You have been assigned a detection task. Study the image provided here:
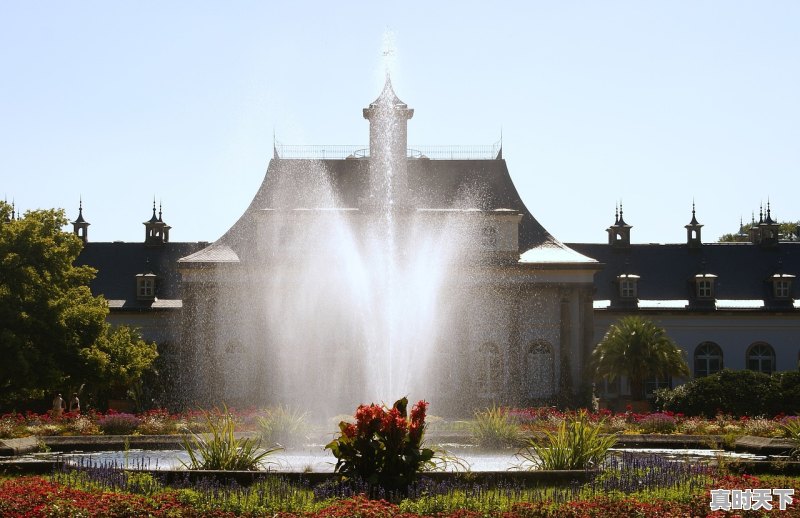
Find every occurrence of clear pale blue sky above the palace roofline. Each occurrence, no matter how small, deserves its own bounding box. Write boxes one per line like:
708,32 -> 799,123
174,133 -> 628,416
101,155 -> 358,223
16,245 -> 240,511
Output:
0,0 -> 800,246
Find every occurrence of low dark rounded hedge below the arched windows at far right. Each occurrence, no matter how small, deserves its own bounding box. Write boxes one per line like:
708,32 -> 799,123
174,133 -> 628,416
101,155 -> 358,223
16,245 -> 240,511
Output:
654,369 -> 800,417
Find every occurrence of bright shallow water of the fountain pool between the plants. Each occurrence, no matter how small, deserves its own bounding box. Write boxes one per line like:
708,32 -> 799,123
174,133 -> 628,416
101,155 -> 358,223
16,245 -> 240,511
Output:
28,448 -> 766,473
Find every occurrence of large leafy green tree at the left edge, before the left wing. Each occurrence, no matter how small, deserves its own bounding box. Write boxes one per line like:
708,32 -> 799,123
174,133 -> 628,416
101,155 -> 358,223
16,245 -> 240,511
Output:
0,202 -> 155,408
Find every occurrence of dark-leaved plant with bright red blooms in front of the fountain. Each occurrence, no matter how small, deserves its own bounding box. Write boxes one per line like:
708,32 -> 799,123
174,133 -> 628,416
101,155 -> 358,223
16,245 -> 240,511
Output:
325,398 -> 434,495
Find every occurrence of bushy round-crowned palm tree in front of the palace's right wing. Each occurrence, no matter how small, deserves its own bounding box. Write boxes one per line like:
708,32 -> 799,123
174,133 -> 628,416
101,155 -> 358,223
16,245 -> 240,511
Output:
591,316 -> 689,401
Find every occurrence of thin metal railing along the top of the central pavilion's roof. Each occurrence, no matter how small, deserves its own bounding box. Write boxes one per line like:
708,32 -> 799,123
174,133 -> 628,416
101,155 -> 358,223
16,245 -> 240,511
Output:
275,142 -> 501,160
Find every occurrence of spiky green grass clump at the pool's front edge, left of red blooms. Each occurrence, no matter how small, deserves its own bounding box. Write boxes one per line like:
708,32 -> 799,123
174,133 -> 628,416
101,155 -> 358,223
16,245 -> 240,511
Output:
183,408 -> 280,471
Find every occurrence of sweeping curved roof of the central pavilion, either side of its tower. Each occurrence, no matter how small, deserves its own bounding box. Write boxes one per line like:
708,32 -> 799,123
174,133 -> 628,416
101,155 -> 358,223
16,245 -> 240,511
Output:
180,158 -> 564,262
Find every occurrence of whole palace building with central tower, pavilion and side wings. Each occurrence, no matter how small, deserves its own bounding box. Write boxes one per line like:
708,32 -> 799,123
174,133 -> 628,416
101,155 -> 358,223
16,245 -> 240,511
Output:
73,79 -> 800,414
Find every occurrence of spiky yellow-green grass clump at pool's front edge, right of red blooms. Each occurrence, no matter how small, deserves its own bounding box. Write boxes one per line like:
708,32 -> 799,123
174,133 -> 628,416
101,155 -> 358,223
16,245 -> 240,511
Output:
517,410 -> 617,470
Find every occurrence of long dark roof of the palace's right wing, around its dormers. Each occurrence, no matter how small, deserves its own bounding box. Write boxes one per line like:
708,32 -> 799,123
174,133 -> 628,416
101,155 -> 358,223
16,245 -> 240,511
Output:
567,242 -> 800,305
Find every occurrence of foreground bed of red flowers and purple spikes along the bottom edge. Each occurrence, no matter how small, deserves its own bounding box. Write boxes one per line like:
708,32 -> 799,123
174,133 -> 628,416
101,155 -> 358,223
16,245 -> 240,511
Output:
0,466 -> 800,518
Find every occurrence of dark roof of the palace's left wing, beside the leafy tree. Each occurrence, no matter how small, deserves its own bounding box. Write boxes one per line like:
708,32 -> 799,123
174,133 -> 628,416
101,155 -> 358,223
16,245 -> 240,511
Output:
75,242 -> 206,309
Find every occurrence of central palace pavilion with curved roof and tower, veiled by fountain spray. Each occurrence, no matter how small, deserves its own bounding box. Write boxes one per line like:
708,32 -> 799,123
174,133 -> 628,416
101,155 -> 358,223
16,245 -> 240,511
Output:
177,58 -> 596,416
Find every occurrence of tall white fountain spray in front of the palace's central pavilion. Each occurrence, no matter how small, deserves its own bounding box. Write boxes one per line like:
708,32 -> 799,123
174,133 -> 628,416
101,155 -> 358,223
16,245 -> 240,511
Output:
180,77 -> 489,415
